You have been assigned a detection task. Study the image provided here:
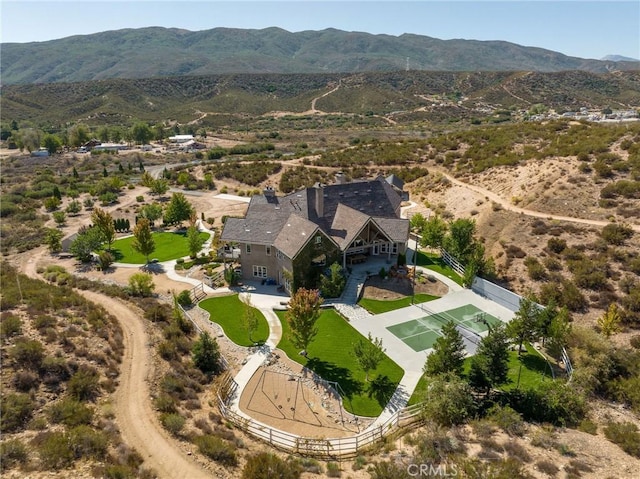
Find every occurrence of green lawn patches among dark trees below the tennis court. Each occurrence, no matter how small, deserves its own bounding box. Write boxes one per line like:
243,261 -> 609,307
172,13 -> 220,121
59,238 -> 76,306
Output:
409,344 -> 553,405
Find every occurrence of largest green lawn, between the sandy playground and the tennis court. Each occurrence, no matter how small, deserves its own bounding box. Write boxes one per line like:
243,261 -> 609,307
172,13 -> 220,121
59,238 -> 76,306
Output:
276,309 -> 404,417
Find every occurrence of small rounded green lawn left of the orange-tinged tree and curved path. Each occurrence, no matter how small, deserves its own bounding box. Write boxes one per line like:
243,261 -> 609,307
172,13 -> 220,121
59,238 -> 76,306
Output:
199,294 -> 269,346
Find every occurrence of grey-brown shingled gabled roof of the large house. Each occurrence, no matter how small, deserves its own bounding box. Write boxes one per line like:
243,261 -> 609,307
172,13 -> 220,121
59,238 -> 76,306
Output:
221,177 -> 409,258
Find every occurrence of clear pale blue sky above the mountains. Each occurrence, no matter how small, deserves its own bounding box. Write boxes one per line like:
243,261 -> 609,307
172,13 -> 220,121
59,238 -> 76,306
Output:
0,0 -> 640,58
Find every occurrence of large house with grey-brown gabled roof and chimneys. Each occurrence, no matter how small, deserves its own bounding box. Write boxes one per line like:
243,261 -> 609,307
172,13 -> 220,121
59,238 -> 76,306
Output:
221,174 -> 409,293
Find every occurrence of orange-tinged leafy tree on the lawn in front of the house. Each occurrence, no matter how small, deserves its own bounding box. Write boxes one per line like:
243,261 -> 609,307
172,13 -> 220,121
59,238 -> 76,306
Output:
286,288 -> 323,351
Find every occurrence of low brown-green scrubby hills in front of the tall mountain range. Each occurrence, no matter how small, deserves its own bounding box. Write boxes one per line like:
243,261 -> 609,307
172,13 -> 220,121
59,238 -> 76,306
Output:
0,71 -> 640,125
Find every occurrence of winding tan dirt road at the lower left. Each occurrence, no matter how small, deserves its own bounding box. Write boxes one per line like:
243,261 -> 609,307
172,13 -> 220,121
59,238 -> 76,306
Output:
20,248 -> 211,479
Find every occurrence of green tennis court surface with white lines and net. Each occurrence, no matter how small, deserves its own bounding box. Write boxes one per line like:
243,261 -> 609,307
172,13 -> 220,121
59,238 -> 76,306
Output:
387,304 -> 501,352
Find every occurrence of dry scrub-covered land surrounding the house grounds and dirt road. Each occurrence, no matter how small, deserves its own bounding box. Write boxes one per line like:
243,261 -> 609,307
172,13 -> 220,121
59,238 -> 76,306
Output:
1,117 -> 640,478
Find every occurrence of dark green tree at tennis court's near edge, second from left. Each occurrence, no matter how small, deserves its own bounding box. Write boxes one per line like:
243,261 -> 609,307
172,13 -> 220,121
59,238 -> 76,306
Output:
469,325 -> 509,394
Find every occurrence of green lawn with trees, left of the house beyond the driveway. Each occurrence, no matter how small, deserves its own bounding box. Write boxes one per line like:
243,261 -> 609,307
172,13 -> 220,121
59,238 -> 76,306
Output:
111,231 -> 209,264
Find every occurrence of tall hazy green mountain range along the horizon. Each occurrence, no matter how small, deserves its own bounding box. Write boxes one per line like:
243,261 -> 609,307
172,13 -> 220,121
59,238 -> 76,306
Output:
0,27 -> 640,85
